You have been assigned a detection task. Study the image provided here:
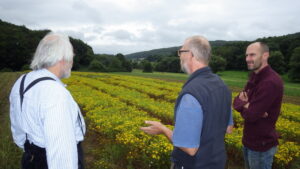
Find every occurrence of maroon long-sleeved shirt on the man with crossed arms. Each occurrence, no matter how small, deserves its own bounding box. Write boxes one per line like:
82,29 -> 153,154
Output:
233,66 -> 283,152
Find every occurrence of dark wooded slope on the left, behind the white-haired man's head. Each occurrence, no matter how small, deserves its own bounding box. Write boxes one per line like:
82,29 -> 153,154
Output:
0,20 -> 132,72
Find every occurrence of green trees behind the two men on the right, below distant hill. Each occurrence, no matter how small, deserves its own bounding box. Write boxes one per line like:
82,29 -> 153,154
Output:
130,33 -> 300,81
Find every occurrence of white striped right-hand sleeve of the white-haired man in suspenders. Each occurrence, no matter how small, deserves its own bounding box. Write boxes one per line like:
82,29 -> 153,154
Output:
41,87 -> 78,169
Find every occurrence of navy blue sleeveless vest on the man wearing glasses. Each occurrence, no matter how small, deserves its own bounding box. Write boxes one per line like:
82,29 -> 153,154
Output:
171,67 -> 231,169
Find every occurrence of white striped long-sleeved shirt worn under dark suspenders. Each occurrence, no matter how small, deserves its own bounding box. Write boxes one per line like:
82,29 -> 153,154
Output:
9,69 -> 85,169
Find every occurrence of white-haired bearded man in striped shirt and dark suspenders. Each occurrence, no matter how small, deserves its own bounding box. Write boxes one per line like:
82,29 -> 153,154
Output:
10,33 -> 85,169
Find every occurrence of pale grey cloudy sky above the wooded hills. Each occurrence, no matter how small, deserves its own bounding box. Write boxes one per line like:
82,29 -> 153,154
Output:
0,0 -> 300,54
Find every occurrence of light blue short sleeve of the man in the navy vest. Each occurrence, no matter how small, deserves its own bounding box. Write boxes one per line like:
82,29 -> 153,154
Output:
172,94 -> 203,148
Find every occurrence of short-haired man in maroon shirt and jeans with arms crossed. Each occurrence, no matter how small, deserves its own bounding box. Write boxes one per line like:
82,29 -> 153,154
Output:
233,42 -> 283,169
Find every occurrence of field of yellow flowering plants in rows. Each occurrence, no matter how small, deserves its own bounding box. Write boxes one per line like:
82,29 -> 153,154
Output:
64,72 -> 300,169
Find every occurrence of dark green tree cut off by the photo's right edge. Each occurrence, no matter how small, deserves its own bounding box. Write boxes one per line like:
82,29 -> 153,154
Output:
288,46 -> 300,81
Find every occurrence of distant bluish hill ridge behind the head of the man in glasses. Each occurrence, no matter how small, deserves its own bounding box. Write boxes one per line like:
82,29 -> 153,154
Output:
125,40 -> 246,59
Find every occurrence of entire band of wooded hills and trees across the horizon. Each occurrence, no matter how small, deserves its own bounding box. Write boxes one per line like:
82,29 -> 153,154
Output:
0,20 -> 300,81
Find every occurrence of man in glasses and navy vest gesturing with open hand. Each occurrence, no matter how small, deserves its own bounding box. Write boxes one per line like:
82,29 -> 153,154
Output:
141,36 -> 233,169
